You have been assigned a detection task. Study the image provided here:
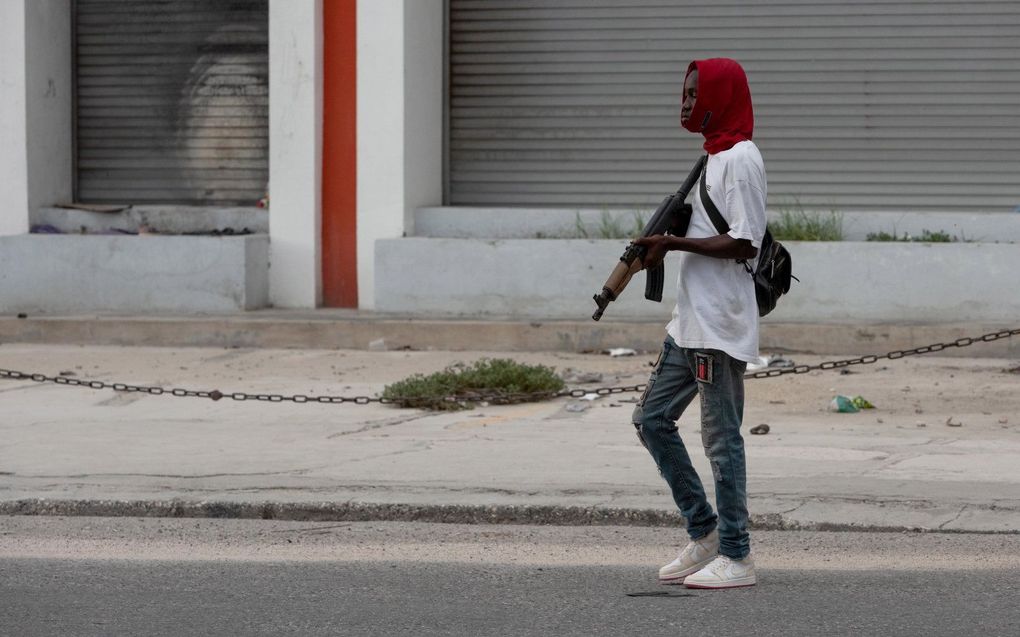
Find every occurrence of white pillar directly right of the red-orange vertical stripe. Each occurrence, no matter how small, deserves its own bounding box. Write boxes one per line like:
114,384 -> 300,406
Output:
357,0 -> 444,309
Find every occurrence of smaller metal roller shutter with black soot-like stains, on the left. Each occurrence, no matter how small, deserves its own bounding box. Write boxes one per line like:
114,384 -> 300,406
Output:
74,0 -> 269,205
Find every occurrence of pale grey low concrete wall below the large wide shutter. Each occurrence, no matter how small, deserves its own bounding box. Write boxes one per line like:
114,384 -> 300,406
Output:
375,237 -> 1020,323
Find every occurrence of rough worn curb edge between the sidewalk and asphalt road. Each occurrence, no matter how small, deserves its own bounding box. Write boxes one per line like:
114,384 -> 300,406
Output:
0,498 -> 1020,535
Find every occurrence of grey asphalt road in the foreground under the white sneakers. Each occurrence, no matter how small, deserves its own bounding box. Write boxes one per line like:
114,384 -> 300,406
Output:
0,518 -> 1020,636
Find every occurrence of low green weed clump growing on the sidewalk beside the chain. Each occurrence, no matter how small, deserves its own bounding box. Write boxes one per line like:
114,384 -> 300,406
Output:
383,359 -> 564,411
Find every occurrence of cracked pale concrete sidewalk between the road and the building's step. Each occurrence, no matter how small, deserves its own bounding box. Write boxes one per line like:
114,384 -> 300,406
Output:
0,332 -> 1020,533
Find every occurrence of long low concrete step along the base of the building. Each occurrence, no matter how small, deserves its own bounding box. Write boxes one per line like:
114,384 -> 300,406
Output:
0,310 -> 1020,358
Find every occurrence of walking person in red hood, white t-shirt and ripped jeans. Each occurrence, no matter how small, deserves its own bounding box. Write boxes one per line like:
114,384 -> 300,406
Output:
633,58 -> 766,588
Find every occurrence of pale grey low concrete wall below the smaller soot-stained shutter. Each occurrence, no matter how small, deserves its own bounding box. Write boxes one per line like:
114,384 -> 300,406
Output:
0,234 -> 269,313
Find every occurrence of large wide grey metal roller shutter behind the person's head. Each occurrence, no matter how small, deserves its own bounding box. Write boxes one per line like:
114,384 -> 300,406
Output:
448,0 -> 1020,212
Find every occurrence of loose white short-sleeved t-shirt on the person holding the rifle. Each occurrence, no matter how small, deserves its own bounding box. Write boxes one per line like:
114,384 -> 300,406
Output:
666,141 -> 767,363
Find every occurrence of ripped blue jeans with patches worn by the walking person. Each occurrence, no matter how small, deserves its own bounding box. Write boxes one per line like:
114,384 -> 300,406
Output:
632,336 -> 751,560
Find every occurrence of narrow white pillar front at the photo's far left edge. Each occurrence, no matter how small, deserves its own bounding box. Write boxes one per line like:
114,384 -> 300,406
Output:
0,0 -> 29,236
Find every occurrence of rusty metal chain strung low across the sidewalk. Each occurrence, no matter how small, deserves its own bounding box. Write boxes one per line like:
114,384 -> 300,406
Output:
0,328 -> 1020,407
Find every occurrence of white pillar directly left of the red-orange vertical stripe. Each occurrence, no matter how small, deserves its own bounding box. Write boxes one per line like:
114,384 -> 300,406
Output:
269,0 -> 322,308
